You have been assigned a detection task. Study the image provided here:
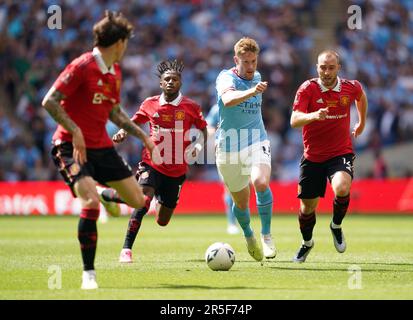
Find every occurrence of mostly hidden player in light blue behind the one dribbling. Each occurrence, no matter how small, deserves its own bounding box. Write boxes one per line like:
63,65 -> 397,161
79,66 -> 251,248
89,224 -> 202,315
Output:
205,104 -> 239,234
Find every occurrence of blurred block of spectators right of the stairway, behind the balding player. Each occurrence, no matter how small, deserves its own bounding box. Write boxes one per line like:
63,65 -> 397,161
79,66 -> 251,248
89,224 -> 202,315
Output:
337,0 -> 413,152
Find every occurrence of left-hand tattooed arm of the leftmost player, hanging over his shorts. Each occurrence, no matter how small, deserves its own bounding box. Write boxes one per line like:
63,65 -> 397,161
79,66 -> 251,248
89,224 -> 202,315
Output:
42,87 -> 87,164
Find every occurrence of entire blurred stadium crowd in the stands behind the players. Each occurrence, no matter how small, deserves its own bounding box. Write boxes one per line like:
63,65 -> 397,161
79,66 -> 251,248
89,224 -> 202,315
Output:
0,0 -> 413,181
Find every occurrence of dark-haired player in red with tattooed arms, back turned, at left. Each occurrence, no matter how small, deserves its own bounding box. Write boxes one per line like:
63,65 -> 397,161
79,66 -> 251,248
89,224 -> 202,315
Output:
42,12 -> 159,289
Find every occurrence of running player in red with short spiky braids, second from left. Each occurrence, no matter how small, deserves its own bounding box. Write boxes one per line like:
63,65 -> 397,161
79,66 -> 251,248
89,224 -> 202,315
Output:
98,60 -> 208,262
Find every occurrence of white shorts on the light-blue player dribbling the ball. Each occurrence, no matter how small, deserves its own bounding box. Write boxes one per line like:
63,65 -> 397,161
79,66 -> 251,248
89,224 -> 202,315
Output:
216,140 -> 271,192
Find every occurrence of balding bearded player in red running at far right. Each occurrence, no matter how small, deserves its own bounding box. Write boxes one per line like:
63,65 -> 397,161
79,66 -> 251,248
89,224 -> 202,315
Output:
290,50 -> 367,262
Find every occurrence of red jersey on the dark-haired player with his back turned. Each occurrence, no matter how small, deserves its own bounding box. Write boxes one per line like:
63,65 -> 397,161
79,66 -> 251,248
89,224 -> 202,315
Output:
53,48 -> 122,149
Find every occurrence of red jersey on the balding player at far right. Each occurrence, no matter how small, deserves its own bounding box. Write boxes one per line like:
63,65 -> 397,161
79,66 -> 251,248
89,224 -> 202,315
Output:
293,78 -> 363,162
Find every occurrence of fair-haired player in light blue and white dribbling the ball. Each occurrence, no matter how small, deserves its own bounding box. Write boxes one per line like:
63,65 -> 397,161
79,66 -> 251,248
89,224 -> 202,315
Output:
216,37 -> 276,261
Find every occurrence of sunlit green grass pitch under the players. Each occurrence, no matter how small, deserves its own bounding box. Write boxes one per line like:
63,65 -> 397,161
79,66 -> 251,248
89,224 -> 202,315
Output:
0,215 -> 413,300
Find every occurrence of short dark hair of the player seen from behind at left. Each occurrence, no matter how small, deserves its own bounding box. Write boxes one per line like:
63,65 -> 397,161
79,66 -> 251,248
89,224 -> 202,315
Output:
93,10 -> 133,48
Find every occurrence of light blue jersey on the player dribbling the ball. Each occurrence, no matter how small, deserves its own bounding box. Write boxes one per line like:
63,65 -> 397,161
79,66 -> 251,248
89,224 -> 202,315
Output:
216,68 -> 267,152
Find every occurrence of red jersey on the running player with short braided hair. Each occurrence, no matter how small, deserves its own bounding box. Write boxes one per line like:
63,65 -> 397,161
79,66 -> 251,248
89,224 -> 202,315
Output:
132,94 -> 207,177
